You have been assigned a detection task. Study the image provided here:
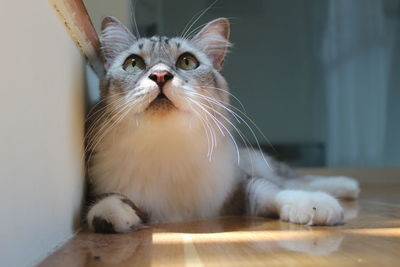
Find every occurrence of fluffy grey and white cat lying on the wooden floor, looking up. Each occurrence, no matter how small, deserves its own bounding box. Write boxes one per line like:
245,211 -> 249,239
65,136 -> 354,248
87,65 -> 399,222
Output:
86,17 -> 360,233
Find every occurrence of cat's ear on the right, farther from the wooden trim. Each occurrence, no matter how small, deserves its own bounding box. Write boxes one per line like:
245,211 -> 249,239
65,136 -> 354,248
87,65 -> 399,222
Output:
192,18 -> 230,70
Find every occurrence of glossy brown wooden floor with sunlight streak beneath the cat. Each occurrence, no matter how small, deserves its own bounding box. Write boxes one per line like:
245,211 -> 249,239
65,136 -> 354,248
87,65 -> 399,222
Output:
40,170 -> 400,267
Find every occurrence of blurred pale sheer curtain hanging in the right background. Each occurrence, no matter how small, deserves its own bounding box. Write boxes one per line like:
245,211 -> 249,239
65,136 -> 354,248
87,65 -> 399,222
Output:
321,0 -> 400,166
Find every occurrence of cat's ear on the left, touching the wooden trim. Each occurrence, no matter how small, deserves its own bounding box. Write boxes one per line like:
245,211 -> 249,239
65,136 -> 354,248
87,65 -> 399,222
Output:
100,17 -> 136,70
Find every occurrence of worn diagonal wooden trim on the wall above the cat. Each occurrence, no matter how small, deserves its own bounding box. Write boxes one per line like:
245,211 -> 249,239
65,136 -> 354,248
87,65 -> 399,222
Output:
49,0 -> 104,77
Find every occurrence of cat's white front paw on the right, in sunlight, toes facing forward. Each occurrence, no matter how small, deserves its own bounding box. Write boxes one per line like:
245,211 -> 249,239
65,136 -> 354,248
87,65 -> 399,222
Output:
276,190 -> 343,225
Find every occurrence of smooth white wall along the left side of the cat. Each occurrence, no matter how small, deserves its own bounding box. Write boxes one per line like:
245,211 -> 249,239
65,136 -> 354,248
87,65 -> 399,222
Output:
0,0 -> 85,266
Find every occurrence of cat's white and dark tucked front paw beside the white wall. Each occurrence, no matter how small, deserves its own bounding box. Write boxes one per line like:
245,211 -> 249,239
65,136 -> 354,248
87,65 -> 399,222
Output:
86,193 -> 147,233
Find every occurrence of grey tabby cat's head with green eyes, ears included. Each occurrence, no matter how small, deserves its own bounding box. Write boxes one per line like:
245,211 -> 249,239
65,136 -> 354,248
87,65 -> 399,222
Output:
100,17 -> 229,121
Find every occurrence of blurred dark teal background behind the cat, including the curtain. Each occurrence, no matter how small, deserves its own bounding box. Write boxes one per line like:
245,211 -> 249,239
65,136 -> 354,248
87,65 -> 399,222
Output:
84,0 -> 400,167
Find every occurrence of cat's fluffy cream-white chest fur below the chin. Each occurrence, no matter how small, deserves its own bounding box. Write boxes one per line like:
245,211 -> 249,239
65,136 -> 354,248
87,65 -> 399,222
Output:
90,113 -> 237,222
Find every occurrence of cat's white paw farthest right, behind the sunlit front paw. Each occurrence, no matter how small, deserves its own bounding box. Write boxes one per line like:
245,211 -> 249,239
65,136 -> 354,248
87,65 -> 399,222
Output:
310,176 -> 360,199
